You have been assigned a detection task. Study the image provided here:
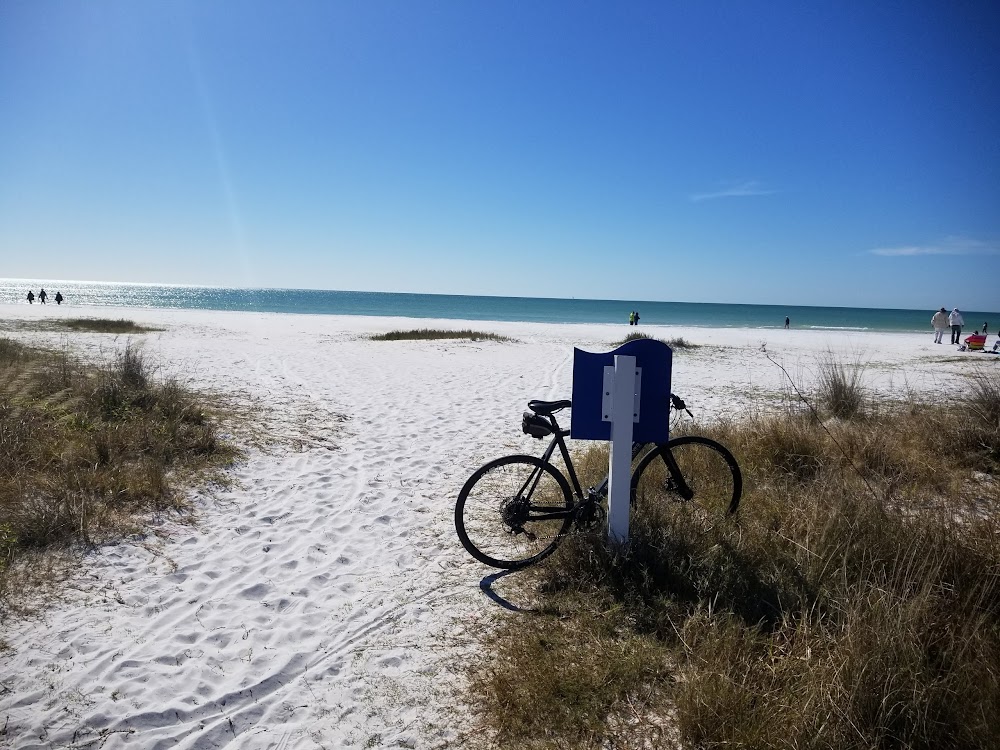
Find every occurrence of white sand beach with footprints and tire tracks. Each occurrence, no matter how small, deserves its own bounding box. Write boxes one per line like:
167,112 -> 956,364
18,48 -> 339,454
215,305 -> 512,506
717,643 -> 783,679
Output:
0,305 -> 1000,750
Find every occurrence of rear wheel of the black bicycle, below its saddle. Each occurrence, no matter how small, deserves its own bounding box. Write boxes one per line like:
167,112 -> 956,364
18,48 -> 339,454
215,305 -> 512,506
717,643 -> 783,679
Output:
455,455 -> 573,569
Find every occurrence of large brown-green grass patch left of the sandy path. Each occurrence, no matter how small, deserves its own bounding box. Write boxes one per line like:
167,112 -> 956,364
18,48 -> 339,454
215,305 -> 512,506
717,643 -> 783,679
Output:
0,339 -> 237,606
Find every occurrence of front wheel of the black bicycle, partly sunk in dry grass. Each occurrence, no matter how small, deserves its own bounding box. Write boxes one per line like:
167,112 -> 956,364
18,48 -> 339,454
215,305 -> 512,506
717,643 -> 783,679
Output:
632,435 -> 743,516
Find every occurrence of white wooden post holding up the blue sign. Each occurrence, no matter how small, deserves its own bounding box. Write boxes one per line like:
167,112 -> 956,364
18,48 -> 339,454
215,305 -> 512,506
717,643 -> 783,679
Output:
602,354 -> 642,544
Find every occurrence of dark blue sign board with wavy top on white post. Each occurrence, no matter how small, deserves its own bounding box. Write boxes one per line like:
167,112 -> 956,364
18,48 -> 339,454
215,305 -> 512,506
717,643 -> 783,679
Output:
570,339 -> 674,443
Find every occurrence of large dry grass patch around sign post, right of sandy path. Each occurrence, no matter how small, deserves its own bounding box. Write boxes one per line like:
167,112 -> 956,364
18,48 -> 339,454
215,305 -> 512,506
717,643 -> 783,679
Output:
469,362 -> 1000,750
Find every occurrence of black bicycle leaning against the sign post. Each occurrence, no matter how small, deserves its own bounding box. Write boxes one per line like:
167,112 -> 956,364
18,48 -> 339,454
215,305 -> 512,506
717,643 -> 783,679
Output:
455,394 -> 743,570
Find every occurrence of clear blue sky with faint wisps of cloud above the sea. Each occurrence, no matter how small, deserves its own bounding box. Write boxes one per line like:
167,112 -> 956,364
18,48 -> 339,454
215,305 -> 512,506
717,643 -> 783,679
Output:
0,0 -> 1000,310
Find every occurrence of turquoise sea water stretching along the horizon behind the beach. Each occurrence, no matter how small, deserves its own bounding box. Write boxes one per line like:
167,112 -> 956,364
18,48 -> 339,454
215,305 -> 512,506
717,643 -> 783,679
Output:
0,279 -> 1000,332
